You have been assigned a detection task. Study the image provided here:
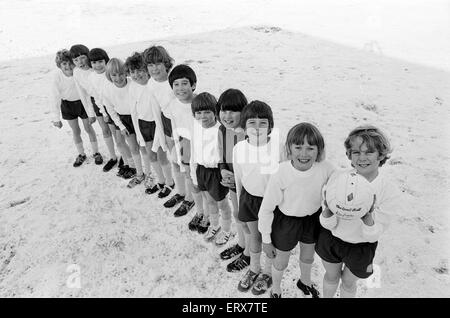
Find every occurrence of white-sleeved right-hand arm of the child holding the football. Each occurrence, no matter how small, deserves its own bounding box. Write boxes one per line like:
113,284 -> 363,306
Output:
361,184 -> 401,242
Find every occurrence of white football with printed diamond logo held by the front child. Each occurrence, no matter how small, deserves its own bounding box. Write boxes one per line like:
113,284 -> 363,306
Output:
324,171 -> 375,220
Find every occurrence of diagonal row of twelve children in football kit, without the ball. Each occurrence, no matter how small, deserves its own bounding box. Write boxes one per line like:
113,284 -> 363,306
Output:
53,45 -> 398,297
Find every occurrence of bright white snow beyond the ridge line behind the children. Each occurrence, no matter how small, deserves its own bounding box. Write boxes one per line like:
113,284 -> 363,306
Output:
0,0 -> 450,70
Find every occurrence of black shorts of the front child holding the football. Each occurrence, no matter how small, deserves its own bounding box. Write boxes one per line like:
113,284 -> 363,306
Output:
315,228 -> 378,278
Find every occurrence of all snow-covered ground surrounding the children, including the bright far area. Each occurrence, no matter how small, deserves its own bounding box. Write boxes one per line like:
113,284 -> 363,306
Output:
0,0 -> 450,297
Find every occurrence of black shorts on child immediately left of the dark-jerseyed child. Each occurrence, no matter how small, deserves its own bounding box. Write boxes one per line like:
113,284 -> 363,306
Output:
195,165 -> 228,202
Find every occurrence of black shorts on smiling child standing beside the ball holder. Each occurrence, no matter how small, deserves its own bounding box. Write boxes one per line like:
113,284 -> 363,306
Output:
271,207 -> 322,252
